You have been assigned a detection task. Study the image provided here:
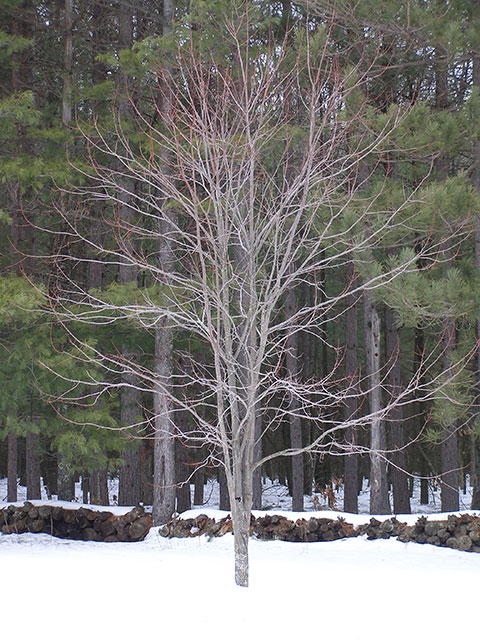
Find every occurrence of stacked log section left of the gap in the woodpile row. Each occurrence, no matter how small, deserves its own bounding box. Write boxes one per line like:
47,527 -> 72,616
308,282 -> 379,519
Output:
0,502 -> 152,542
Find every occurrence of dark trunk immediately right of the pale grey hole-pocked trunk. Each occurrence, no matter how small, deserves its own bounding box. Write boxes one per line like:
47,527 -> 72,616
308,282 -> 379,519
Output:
385,307 -> 411,513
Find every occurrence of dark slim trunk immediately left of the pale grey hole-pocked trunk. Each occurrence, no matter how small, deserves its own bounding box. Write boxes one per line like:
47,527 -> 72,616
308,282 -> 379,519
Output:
343,261 -> 359,513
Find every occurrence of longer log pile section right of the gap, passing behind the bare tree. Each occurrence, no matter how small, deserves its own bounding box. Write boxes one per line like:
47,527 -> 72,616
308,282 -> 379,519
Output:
160,514 -> 480,553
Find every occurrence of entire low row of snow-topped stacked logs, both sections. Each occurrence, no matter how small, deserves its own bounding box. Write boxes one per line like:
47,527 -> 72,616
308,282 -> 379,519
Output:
0,502 -> 480,553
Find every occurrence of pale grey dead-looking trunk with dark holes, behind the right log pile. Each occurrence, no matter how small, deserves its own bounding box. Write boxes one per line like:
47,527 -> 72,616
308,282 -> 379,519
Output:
363,290 -> 390,514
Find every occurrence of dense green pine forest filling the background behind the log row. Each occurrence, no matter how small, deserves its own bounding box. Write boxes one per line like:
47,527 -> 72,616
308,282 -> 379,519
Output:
0,0 -> 480,556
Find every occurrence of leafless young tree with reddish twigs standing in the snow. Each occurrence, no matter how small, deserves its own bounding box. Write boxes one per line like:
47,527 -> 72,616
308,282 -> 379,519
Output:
49,16 -> 462,586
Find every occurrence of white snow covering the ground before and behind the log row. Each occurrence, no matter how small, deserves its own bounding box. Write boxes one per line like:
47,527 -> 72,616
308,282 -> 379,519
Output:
0,481 -> 480,640
